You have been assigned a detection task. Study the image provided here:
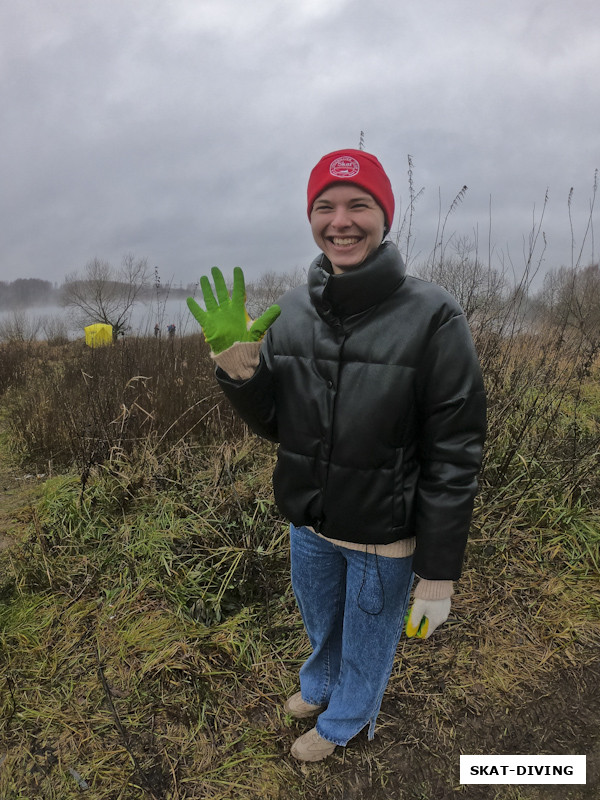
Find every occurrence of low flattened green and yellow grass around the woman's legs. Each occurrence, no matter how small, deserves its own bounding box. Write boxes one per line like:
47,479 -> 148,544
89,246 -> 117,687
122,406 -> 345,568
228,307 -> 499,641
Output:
0,432 -> 600,800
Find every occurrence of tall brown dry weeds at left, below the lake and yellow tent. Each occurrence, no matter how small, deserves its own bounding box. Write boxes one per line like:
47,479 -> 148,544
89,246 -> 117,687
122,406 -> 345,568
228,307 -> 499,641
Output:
0,334 -> 244,471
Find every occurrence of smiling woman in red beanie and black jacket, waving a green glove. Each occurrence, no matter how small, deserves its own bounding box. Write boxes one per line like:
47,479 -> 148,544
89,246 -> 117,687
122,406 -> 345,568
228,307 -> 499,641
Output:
189,149 -> 485,761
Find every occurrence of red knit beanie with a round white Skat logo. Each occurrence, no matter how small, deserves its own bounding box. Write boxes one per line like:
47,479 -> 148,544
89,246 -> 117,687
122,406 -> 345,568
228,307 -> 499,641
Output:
307,149 -> 394,230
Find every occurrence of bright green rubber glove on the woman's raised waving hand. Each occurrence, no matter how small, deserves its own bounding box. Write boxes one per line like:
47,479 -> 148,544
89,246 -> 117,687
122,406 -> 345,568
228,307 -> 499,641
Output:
187,267 -> 281,355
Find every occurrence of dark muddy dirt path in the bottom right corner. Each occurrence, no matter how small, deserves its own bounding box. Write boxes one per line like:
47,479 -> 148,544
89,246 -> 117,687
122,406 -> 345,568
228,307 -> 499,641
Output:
296,658 -> 600,800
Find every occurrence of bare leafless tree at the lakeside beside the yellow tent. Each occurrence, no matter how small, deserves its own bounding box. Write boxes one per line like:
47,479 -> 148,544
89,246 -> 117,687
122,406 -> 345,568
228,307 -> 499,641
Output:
62,253 -> 149,338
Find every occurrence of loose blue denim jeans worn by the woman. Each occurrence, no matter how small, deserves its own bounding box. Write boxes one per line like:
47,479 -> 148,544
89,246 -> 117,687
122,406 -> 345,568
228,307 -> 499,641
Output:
290,525 -> 414,746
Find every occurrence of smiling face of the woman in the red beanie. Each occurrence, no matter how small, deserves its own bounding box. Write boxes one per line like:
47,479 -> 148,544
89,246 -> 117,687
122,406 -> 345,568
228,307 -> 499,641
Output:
310,183 -> 385,274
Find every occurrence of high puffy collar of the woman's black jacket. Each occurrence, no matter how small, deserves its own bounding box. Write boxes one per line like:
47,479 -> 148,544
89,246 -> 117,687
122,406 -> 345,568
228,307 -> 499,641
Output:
308,242 -> 406,321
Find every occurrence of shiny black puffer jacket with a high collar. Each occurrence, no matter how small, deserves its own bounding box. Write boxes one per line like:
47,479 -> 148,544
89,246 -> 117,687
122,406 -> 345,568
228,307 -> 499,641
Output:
217,242 -> 485,580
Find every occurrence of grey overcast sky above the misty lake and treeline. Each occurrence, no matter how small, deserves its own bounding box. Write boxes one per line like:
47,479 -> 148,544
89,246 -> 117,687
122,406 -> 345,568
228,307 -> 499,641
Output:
0,0 -> 600,285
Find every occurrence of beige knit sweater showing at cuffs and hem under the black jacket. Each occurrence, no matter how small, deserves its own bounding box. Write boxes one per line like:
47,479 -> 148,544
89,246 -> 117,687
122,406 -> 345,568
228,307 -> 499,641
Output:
212,342 -> 454,600
